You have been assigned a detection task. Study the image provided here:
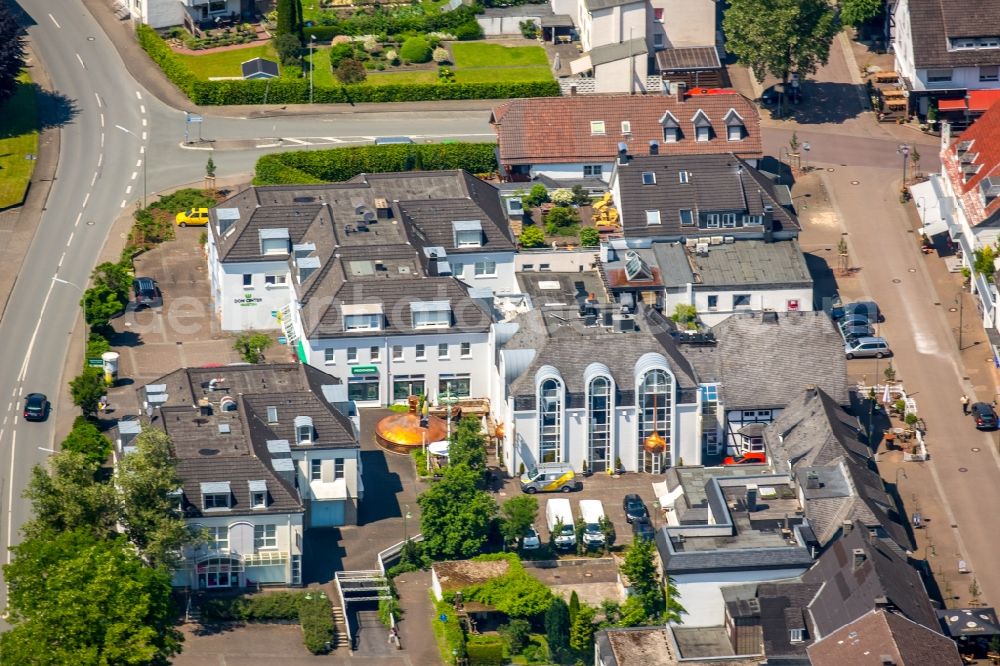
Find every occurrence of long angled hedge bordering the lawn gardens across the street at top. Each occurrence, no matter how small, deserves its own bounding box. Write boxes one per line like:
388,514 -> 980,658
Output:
136,24 -> 559,106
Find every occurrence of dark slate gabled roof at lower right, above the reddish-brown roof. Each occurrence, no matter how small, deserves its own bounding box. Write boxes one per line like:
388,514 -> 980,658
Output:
802,524 -> 939,635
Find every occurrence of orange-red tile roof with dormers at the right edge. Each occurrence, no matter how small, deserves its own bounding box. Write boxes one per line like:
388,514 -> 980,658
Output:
941,104 -> 1000,227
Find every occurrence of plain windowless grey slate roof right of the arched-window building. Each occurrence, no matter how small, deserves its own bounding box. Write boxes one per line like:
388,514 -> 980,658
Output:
704,312 -> 850,409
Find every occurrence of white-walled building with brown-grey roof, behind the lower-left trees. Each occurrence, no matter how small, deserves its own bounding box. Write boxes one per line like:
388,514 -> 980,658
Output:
125,364 -> 364,589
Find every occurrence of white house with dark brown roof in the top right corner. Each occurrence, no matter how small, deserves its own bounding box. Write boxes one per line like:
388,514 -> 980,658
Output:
890,0 -> 1000,116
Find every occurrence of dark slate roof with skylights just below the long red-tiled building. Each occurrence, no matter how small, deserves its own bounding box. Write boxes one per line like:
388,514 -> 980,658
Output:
615,153 -> 799,238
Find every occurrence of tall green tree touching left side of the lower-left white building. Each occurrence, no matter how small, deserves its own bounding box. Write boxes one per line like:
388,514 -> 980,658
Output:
115,428 -> 196,568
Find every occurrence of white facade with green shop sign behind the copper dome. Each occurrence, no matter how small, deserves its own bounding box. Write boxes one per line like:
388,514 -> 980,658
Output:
307,332 -> 493,407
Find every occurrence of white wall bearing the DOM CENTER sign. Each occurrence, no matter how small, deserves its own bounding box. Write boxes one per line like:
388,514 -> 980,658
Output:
217,256 -> 294,331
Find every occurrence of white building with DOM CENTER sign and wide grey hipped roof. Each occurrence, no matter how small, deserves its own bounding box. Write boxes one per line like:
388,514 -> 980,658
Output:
207,171 -> 518,331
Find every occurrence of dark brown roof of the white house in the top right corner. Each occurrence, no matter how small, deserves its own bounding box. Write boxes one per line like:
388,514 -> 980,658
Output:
908,0 -> 1000,68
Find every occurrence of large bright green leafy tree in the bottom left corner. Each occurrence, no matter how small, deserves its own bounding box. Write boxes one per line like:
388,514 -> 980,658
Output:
0,531 -> 181,666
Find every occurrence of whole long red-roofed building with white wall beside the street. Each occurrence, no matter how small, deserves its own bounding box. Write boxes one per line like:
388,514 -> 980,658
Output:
490,88 -> 763,187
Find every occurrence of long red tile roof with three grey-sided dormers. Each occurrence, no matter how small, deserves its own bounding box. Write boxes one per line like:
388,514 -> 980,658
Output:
490,91 -> 763,165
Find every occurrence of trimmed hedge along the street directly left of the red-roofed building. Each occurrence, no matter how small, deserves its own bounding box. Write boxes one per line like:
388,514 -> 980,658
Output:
254,143 -> 497,185
